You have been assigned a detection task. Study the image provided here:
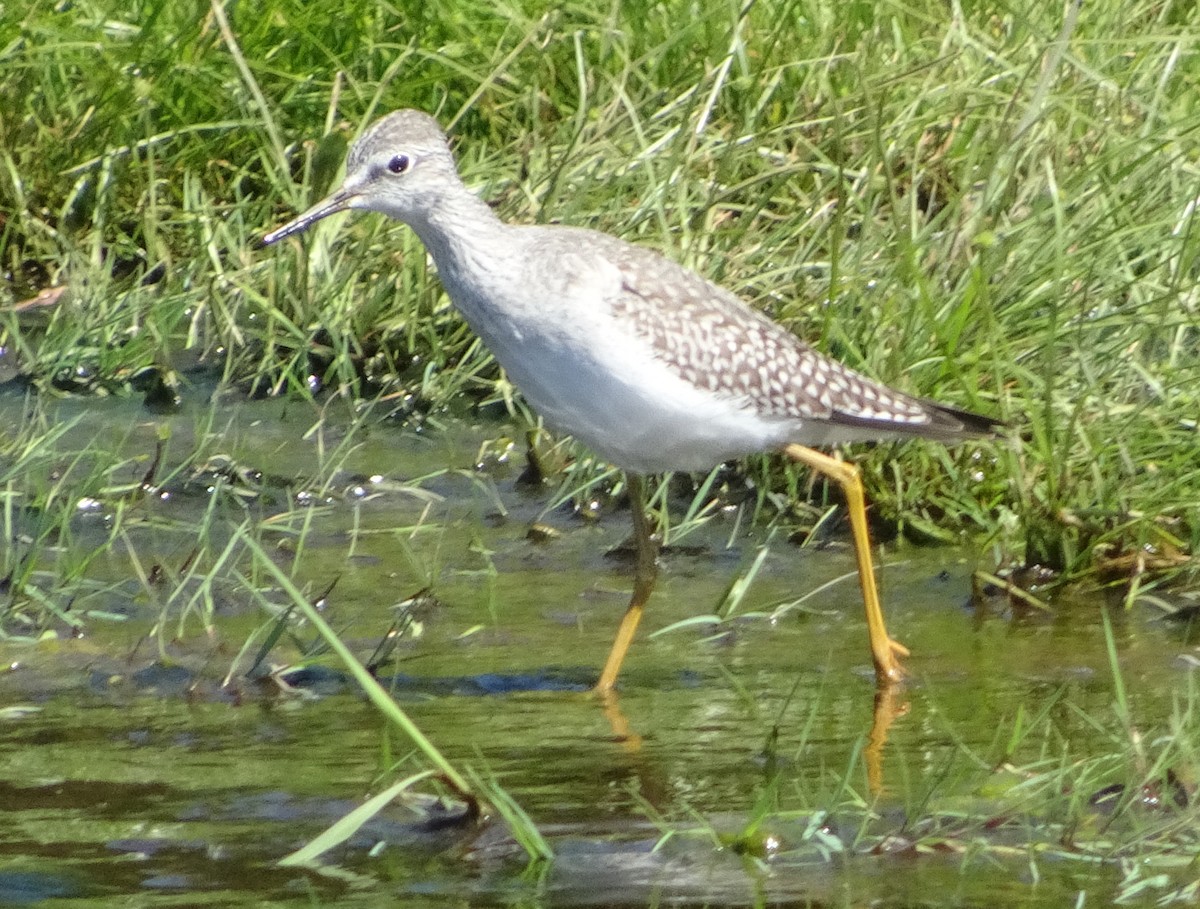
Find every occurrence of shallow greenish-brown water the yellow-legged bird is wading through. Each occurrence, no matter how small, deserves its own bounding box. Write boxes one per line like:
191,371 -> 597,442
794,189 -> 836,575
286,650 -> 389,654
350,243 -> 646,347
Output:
0,390 -> 1190,907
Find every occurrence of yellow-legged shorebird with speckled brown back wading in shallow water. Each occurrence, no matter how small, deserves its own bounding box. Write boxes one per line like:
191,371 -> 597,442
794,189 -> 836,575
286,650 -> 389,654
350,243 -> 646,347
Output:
263,110 -> 997,692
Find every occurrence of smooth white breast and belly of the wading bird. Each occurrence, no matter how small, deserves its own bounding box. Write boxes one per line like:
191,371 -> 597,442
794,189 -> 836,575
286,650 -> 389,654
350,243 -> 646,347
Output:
439,231 -> 798,474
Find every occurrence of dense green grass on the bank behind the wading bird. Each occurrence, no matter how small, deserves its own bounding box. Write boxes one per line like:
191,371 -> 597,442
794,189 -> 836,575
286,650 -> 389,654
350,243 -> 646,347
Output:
0,0 -> 1200,590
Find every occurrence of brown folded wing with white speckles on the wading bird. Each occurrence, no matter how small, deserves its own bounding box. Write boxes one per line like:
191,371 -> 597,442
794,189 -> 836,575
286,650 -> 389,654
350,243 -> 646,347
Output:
608,243 -> 940,437
